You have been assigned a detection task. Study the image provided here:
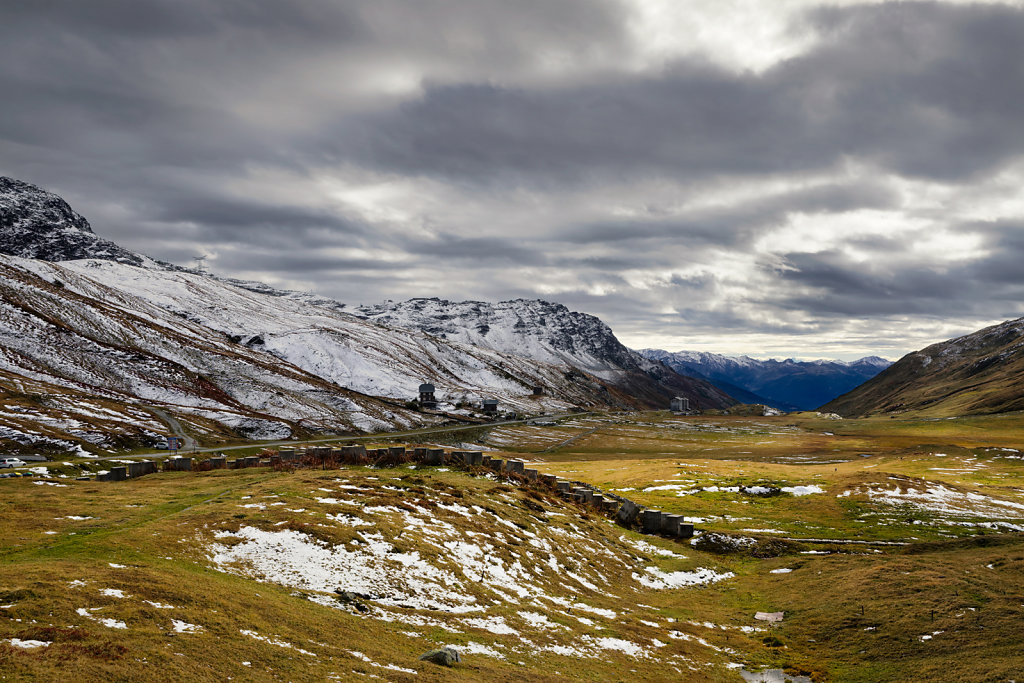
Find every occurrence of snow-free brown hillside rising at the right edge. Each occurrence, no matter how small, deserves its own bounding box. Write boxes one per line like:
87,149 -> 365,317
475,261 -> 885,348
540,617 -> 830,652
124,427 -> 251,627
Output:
821,318 -> 1024,417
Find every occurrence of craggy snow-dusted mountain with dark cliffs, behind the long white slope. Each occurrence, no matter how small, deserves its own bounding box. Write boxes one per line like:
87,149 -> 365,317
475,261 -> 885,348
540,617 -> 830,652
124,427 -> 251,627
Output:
353,298 -> 735,408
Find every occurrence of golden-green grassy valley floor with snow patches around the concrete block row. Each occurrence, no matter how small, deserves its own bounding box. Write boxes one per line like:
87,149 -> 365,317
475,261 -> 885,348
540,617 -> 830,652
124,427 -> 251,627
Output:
0,413 -> 1024,681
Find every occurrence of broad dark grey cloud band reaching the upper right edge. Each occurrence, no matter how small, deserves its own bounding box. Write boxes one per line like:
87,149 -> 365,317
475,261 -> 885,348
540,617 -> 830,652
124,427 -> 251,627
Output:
342,3 -> 1024,182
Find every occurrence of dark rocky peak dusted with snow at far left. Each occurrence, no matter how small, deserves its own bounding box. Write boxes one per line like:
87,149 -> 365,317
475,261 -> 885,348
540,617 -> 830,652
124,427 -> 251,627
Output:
0,176 -> 147,265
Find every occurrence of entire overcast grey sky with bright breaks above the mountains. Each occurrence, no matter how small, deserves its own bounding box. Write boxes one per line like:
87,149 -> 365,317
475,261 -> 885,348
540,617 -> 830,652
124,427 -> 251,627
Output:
0,0 -> 1024,359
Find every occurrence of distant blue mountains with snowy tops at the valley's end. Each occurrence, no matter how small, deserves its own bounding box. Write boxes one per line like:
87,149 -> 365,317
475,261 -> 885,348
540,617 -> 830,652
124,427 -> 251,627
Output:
640,349 -> 892,411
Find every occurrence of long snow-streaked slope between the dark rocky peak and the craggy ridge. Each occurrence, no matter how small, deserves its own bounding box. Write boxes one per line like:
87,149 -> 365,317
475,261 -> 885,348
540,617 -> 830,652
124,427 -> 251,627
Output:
0,250 -> 629,454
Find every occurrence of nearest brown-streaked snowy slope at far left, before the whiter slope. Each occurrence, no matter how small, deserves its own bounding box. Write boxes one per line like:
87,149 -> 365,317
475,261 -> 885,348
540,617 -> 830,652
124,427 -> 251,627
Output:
0,256 -> 431,442
